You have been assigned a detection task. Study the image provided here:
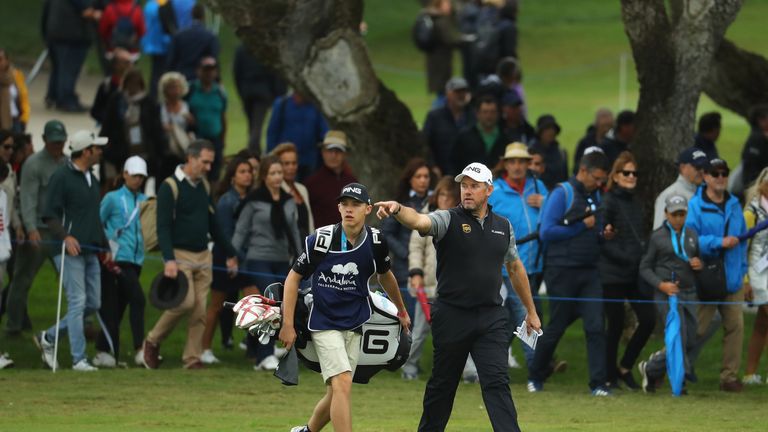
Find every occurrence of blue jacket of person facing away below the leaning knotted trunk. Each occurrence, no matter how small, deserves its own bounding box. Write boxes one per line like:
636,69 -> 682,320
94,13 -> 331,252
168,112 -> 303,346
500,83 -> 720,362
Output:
267,95 -> 328,172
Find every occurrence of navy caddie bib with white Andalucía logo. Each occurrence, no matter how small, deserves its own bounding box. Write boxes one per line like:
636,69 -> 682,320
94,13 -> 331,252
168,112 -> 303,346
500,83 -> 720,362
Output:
308,225 -> 380,331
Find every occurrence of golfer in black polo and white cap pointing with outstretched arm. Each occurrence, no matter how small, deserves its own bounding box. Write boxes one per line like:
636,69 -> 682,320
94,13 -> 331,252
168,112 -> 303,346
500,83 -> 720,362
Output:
375,163 -> 541,432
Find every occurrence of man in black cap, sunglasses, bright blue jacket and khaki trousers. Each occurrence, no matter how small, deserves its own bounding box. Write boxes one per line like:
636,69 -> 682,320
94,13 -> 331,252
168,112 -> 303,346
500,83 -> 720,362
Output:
685,159 -> 747,392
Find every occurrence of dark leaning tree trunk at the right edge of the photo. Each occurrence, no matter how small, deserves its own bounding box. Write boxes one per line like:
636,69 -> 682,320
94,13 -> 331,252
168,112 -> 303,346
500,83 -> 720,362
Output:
704,39 -> 768,119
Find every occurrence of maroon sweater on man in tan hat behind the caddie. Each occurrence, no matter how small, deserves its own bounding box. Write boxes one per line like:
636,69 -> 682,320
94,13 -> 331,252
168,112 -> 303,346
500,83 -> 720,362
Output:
304,164 -> 357,228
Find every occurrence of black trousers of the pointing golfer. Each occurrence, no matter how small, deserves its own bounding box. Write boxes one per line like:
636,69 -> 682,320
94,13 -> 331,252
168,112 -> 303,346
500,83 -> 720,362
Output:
418,301 -> 520,432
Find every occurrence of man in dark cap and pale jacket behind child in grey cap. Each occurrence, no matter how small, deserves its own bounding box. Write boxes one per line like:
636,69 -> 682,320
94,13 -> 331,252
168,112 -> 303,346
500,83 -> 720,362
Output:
653,147 -> 709,230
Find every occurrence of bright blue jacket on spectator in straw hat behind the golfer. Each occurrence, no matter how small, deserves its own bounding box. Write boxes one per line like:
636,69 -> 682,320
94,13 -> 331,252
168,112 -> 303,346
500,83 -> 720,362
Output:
488,177 -> 549,276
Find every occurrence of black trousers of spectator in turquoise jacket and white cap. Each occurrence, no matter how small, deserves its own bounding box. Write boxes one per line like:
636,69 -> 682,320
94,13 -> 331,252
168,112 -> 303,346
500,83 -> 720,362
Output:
96,262 -> 146,359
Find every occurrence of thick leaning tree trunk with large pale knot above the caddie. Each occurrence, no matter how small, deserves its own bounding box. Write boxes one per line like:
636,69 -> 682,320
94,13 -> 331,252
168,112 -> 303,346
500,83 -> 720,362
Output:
206,0 -> 425,200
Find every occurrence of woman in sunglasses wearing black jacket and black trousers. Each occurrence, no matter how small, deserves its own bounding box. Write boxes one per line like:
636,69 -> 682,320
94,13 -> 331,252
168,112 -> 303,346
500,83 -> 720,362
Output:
599,152 -> 656,390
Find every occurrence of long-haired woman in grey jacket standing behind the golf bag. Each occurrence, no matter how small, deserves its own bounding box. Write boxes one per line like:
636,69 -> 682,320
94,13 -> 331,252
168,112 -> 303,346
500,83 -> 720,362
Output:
232,156 -> 302,370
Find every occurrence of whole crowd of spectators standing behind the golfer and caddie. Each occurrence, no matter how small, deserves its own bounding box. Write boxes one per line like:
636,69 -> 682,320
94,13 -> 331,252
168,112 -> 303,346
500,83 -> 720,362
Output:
0,0 -> 768,402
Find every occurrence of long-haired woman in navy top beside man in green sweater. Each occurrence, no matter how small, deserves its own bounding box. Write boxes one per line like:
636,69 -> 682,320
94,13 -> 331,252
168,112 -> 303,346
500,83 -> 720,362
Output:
200,157 -> 253,364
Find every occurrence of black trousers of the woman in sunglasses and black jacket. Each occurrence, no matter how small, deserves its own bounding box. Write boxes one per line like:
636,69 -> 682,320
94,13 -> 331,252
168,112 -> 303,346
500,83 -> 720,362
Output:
603,283 -> 656,381
